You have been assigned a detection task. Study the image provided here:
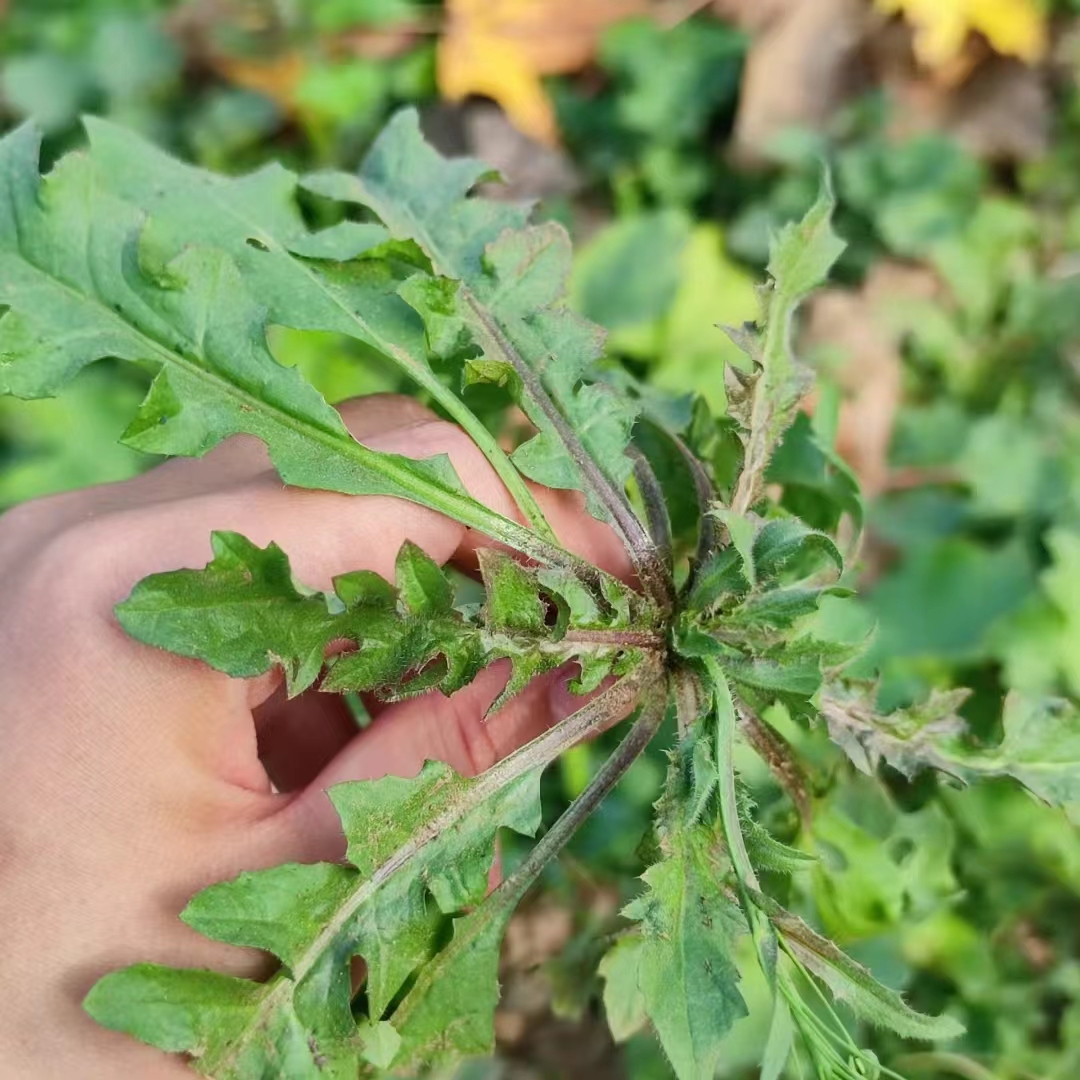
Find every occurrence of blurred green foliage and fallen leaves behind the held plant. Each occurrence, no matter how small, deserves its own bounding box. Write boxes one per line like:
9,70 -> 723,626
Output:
6,0 -> 1080,1080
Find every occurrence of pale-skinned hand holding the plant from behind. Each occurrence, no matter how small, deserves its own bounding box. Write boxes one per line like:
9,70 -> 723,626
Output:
0,396 -> 626,1080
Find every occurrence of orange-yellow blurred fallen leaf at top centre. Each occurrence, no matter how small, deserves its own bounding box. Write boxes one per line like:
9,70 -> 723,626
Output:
437,0 -> 649,145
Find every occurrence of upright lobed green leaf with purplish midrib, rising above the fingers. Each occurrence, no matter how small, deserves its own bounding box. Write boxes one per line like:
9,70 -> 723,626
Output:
305,110 -> 634,517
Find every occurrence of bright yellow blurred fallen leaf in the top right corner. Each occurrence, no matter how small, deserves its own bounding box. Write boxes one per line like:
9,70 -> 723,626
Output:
877,0 -> 1048,68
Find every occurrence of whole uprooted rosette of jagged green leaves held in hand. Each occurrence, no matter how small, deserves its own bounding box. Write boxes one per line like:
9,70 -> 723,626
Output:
0,112 -> 1080,1080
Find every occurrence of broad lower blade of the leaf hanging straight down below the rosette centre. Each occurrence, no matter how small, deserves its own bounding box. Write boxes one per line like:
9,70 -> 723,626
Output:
624,827 -> 746,1080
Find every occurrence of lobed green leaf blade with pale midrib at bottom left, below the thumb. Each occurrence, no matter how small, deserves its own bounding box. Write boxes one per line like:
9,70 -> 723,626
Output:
85,755 -> 540,1080
